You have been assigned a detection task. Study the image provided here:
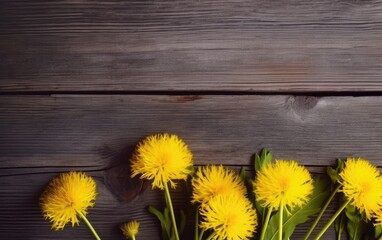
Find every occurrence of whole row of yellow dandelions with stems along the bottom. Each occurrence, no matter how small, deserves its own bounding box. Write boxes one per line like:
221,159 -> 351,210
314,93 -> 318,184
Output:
40,134 -> 382,240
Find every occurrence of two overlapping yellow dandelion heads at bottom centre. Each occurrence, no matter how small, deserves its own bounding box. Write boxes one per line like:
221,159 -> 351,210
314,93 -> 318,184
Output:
192,166 -> 257,240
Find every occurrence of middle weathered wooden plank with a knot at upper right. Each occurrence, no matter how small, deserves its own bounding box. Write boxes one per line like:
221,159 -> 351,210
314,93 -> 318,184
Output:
0,95 -> 382,168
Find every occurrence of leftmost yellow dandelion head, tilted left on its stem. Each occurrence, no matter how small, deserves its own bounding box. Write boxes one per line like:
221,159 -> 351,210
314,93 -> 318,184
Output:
40,172 -> 97,230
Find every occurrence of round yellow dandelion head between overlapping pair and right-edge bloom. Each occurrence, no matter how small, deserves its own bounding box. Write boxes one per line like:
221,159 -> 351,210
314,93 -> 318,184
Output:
254,160 -> 313,209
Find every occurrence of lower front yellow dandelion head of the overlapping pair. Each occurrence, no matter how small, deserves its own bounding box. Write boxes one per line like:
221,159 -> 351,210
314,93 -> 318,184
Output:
200,194 -> 257,240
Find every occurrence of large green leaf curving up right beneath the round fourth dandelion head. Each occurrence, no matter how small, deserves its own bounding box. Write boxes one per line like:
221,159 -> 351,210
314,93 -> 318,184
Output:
265,177 -> 331,240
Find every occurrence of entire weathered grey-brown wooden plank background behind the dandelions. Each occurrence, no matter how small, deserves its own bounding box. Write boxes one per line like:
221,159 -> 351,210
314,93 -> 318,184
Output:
0,0 -> 382,240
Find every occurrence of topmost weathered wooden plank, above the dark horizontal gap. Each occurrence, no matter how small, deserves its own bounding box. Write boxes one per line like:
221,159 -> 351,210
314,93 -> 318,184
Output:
0,0 -> 382,92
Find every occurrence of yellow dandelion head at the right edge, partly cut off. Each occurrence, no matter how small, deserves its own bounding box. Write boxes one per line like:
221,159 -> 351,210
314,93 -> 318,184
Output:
340,158 -> 382,220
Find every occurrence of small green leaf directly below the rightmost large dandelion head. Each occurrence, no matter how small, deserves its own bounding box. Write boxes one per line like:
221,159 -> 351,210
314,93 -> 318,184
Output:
345,204 -> 367,240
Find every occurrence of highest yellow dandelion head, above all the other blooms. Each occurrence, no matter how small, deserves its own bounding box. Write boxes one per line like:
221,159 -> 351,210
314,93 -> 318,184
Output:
131,134 -> 193,189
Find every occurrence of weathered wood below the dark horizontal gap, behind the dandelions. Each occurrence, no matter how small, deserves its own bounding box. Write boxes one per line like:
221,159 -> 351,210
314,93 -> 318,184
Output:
0,95 -> 382,240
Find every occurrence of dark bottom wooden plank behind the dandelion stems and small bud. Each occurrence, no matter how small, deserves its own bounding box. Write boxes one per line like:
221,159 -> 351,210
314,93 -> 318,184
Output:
0,168 -> 334,240
